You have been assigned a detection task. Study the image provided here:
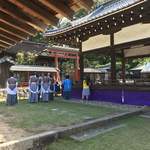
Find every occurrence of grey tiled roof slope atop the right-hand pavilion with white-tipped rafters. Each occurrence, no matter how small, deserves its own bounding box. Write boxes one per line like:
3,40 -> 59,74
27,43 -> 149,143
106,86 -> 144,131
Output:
45,0 -> 141,36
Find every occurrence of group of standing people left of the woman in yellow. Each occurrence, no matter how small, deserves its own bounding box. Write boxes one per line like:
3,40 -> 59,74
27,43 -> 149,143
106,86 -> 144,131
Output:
6,73 -> 72,105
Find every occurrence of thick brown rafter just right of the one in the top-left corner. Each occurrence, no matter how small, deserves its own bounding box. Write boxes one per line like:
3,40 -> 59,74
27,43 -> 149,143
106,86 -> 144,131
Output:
8,0 -> 59,26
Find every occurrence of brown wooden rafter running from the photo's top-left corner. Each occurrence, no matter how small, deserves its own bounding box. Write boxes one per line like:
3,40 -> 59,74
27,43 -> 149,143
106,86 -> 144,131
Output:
0,0 -> 47,31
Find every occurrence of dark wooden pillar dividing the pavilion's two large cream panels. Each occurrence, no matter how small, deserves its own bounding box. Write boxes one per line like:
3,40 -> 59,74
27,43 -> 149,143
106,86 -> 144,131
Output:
110,33 -> 116,83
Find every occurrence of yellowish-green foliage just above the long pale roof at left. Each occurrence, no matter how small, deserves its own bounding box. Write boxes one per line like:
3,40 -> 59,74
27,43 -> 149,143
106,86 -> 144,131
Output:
16,52 -> 37,65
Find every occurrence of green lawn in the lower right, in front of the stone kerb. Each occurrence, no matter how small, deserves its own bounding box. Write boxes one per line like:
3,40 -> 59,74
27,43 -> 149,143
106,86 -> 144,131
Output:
48,117 -> 150,150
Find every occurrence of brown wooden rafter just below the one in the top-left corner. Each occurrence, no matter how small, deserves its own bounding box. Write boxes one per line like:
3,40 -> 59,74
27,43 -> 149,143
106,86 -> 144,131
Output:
0,12 -> 36,36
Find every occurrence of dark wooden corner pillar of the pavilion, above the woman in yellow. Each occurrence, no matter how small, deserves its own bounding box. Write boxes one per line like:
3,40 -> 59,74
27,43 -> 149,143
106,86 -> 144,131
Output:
79,42 -> 84,81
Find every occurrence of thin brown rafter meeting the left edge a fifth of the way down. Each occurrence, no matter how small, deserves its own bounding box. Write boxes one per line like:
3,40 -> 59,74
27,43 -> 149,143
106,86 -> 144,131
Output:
0,28 -> 26,41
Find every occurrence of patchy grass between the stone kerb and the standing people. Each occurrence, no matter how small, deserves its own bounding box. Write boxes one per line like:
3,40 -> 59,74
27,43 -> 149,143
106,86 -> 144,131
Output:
0,100 -> 118,133
